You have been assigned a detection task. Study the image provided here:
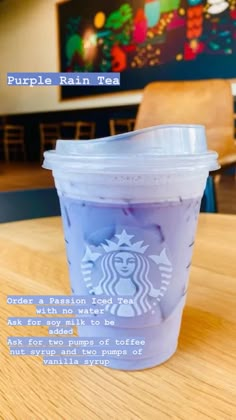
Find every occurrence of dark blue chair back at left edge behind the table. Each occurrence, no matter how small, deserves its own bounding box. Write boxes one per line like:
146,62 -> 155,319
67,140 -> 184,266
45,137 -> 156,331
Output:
0,188 -> 60,223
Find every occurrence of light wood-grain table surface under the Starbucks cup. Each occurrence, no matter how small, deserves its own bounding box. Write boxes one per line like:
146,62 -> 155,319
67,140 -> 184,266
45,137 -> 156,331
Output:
0,214 -> 236,420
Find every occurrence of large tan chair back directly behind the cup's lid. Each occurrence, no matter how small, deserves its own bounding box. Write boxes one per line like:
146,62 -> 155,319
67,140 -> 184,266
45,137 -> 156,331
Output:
135,79 -> 236,157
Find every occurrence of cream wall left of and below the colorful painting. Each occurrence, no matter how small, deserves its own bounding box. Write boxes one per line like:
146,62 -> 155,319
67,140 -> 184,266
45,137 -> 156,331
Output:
0,0 -> 142,115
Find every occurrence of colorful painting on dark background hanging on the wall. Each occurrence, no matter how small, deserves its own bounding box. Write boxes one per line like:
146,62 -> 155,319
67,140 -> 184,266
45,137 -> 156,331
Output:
58,0 -> 236,97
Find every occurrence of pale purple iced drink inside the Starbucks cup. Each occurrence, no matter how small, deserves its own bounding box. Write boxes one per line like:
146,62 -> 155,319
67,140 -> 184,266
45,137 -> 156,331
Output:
60,197 -> 201,369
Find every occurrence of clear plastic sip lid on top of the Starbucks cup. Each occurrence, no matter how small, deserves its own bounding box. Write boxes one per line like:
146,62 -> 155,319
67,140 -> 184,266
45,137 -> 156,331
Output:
43,125 -> 219,173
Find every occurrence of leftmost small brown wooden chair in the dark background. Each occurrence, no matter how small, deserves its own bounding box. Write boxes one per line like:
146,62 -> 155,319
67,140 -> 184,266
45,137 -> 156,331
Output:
3,124 -> 26,162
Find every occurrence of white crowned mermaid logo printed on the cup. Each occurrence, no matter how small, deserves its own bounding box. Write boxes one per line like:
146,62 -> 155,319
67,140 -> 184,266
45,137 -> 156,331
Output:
81,229 -> 172,317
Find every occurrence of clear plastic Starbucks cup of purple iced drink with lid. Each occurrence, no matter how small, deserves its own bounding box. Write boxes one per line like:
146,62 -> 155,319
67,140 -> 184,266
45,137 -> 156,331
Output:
43,125 -> 219,370
